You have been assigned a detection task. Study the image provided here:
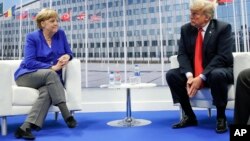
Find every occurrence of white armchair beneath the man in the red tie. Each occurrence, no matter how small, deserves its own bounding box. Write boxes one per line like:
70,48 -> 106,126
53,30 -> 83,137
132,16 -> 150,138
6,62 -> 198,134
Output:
170,52 -> 250,118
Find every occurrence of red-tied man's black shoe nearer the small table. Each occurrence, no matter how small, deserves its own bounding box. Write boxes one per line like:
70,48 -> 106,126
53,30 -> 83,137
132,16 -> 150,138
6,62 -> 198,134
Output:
172,116 -> 198,129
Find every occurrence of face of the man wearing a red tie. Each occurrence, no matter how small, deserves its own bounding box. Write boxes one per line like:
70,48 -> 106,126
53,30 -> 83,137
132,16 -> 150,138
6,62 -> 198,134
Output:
190,10 -> 210,28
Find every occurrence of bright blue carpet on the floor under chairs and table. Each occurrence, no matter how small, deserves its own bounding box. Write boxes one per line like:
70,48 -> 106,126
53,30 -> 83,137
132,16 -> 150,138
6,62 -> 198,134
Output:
0,110 -> 233,141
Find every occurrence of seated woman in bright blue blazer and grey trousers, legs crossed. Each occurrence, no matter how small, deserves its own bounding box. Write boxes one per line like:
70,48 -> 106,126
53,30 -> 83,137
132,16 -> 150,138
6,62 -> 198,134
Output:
15,9 -> 77,140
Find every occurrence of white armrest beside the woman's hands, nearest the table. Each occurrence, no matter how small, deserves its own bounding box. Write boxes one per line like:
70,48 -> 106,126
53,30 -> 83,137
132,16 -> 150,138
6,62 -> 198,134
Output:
64,59 -> 82,110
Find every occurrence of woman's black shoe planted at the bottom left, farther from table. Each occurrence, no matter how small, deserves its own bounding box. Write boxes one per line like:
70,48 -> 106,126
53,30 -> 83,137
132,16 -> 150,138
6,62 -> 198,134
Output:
15,127 -> 35,140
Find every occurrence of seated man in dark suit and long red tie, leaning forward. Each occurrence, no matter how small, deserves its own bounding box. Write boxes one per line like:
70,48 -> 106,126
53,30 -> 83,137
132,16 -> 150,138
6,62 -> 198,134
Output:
166,0 -> 233,133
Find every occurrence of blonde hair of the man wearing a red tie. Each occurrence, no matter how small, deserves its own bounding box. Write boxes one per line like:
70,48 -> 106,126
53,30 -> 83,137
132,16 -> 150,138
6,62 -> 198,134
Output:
190,0 -> 216,19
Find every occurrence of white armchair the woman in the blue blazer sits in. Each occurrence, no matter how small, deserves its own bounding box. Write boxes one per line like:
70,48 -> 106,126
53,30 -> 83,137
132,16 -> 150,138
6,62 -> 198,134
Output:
0,59 -> 81,135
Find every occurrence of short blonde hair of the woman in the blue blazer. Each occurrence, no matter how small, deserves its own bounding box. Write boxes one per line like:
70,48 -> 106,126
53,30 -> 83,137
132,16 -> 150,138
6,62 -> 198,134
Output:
35,8 -> 58,29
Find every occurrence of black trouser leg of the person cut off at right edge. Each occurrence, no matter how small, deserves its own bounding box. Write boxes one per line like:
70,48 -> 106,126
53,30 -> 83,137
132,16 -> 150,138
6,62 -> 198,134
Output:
234,69 -> 250,124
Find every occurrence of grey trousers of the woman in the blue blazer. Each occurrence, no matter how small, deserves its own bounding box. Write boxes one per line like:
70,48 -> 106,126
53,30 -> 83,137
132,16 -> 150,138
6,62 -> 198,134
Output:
16,69 -> 66,127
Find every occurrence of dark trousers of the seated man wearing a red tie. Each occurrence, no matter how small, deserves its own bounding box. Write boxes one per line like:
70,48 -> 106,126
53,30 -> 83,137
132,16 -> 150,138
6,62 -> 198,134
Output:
166,68 -> 233,118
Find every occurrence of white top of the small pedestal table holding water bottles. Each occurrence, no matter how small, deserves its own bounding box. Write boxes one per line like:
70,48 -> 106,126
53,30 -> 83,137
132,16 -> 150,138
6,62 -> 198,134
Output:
100,83 -> 156,89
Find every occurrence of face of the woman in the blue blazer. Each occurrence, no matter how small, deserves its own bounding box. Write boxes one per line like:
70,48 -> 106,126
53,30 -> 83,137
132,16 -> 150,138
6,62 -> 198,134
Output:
41,17 -> 58,34
